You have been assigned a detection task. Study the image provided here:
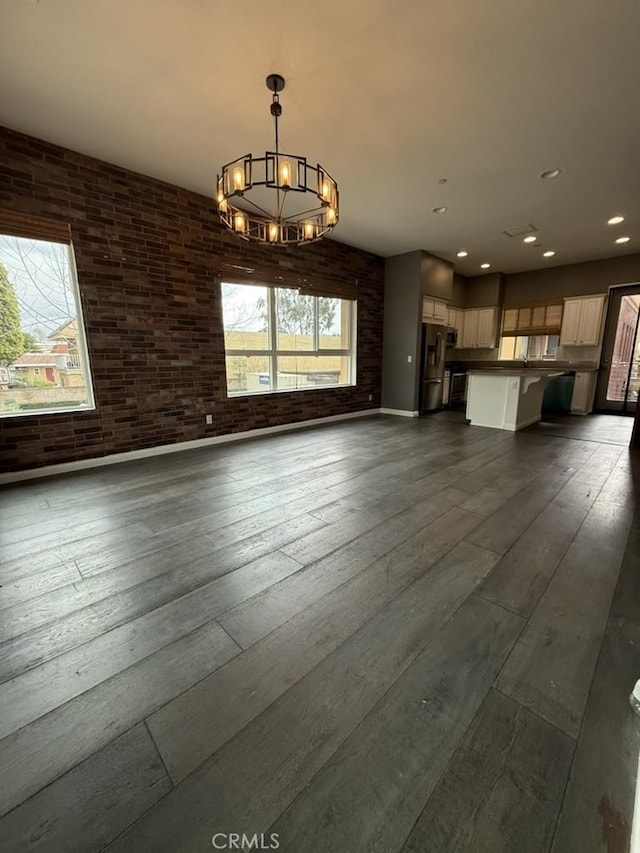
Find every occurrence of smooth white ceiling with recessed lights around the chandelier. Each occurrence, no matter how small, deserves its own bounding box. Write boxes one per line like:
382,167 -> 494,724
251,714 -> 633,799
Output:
0,0 -> 640,275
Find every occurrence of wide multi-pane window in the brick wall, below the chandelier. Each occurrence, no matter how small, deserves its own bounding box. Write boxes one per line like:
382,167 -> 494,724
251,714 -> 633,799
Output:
221,282 -> 355,396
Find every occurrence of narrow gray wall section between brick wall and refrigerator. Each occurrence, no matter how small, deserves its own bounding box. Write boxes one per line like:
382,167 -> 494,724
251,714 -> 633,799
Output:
382,252 -> 422,412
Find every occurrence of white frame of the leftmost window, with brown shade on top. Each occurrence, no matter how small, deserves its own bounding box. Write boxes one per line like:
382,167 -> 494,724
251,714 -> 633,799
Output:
0,231 -> 97,420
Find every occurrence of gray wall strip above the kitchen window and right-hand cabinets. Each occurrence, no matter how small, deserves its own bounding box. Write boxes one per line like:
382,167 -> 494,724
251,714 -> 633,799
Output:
504,254 -> 640,306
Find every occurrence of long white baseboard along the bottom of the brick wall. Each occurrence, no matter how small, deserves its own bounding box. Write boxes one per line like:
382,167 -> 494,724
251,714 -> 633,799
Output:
0,409 -> 381,485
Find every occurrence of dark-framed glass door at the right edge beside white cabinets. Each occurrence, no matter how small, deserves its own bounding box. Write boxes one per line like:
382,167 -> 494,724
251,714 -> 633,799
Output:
596,285 -> 640,414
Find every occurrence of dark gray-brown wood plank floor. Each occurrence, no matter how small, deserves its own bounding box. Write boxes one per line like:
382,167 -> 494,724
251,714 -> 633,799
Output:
0,413 -> 640,853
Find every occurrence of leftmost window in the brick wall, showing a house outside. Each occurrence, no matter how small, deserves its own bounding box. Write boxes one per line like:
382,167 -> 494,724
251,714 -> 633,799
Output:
0,228 -> 93,417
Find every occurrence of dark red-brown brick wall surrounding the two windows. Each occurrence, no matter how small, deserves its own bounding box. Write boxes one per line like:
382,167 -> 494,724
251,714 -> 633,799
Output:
0,128 -> 384,471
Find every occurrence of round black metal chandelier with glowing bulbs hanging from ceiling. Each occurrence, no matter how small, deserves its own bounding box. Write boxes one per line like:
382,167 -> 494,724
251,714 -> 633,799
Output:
216,74 -> 338,245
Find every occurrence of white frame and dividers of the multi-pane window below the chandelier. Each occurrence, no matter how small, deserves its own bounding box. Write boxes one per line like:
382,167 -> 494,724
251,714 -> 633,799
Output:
220,278 -> 358,400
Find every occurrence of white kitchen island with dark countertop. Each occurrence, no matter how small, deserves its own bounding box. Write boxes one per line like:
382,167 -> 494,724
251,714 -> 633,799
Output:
467,367 -> 563,432
